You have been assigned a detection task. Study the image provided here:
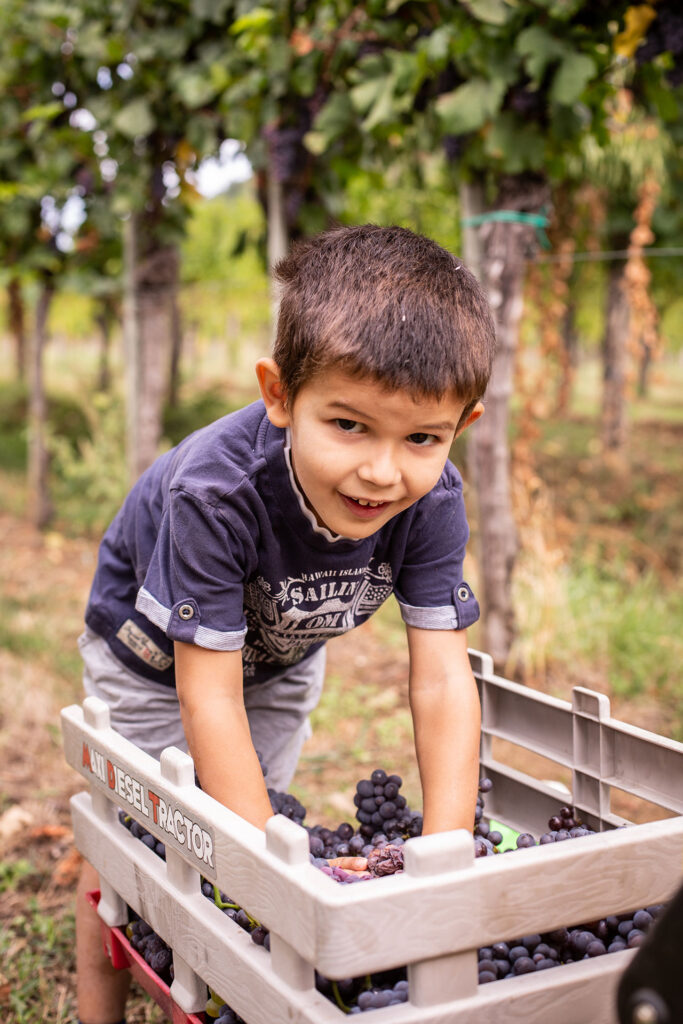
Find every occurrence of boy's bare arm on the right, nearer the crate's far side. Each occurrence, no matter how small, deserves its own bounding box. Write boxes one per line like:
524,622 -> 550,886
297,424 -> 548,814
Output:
407,626 -> 481,835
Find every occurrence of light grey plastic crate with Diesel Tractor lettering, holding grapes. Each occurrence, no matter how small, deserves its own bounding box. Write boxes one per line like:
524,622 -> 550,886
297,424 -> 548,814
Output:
62,651 -> 683,1024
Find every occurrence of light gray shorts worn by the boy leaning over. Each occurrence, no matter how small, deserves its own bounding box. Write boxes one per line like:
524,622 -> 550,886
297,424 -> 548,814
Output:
78,627 -> 326,793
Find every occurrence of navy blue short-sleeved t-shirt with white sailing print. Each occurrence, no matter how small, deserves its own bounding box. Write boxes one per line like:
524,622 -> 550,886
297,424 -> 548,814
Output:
85,401 -> 479,686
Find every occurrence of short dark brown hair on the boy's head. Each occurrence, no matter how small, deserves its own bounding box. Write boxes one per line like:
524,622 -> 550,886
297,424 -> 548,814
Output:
272,224 -> 496,419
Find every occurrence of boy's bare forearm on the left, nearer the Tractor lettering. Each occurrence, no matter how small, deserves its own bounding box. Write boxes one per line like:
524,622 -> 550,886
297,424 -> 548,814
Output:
175,640 -> 272,828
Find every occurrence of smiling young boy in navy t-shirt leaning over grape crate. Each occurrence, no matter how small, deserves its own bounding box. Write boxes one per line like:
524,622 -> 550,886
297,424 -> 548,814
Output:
77,225 -> 495,1024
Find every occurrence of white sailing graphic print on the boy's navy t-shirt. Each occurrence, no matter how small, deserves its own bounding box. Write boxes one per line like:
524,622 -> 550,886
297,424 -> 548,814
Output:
242,559 -> 393,677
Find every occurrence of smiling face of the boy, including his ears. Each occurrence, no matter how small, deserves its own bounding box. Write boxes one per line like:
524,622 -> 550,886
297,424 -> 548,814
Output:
257,359 -> 483,540
